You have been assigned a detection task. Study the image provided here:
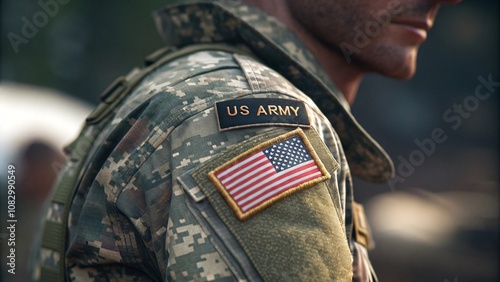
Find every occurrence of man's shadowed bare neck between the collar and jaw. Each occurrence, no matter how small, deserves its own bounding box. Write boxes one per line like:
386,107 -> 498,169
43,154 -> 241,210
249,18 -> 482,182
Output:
245,0 -> 365,104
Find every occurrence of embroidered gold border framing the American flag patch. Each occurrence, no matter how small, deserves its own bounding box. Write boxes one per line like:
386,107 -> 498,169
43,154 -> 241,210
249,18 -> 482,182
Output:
208,128 -> 331,221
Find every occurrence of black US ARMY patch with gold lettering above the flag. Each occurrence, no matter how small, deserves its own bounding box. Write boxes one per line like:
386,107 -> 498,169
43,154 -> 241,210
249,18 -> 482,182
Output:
215,98 -> 310,131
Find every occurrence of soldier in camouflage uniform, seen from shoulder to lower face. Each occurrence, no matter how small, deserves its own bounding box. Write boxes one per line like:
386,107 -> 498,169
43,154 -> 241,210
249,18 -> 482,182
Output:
34,0 -> 455,281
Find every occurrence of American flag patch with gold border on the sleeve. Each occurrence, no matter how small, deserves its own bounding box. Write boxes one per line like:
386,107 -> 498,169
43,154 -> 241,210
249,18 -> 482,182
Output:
208,129 -> 330,220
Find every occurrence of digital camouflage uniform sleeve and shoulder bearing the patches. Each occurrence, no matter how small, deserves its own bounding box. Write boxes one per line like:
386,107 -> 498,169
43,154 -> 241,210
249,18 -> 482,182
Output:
64,49 -> 360,281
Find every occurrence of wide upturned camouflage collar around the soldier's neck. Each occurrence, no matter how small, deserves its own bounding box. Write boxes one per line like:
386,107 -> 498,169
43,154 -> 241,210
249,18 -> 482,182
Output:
155,0 -> 394,182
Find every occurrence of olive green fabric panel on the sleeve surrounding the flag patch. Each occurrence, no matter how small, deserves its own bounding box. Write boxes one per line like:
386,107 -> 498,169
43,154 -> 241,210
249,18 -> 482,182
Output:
192,129 -> 352,281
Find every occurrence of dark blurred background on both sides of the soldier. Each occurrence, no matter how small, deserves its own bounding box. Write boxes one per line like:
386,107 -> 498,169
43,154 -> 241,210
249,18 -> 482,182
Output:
0,0 -> 500,282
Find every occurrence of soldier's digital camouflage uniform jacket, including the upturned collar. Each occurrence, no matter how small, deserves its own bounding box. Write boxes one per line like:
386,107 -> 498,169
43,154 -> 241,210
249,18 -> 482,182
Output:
35,1 -> 393,281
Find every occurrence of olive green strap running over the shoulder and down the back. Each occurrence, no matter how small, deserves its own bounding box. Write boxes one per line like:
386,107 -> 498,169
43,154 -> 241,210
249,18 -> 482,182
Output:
40,44 -> 254,281
